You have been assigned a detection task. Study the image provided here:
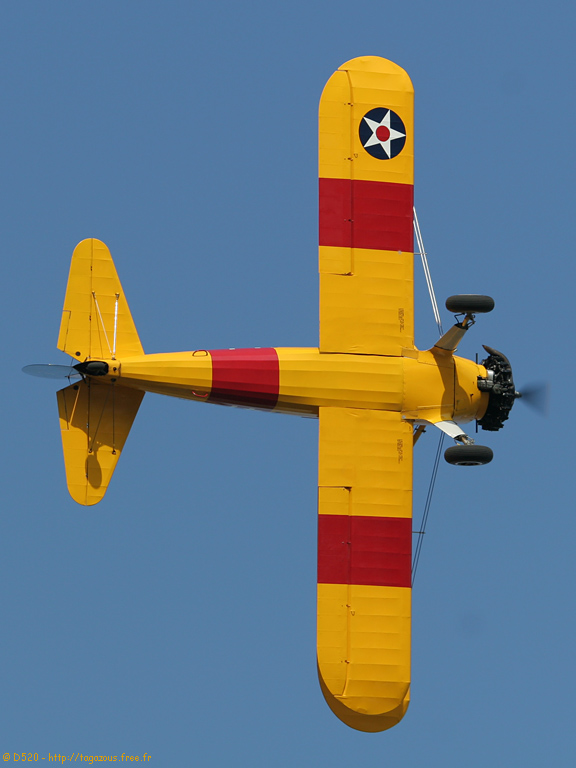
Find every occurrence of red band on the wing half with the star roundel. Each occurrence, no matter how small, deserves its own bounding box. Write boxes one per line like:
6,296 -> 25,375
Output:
319,179 -> 414,253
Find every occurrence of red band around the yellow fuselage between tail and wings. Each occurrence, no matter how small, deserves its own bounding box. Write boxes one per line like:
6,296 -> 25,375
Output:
208,348 -> 280,408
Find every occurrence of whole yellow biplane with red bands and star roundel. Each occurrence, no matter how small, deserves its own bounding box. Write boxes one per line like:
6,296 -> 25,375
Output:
22,56 -> 518,731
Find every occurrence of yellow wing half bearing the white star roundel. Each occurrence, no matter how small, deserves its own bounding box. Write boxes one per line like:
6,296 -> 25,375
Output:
319,56 -> 414,355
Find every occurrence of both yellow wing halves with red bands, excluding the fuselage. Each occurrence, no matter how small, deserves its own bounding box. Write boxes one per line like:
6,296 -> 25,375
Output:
318,56 -> 414,731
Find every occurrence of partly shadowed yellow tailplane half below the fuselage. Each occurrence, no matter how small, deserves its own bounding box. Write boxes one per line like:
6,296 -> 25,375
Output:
57,378 -> 144,506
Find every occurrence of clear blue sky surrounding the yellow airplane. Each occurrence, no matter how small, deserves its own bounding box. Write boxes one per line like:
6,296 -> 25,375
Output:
0,0 -> 576,768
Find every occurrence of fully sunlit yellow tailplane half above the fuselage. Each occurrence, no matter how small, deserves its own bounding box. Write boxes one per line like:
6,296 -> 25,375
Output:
57,238 -> 144,361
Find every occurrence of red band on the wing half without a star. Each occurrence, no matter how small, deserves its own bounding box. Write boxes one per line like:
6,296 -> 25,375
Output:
318,515 -> 412,587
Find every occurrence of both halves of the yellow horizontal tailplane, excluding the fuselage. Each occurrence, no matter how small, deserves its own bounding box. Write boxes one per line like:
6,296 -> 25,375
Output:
57,238 -> 144,506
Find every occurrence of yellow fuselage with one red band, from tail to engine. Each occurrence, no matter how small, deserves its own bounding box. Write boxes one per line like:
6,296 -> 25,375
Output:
92,347 -> 488,423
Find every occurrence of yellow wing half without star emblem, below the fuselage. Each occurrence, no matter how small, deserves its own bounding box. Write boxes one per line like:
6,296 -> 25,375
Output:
318,408 -> 412,731
